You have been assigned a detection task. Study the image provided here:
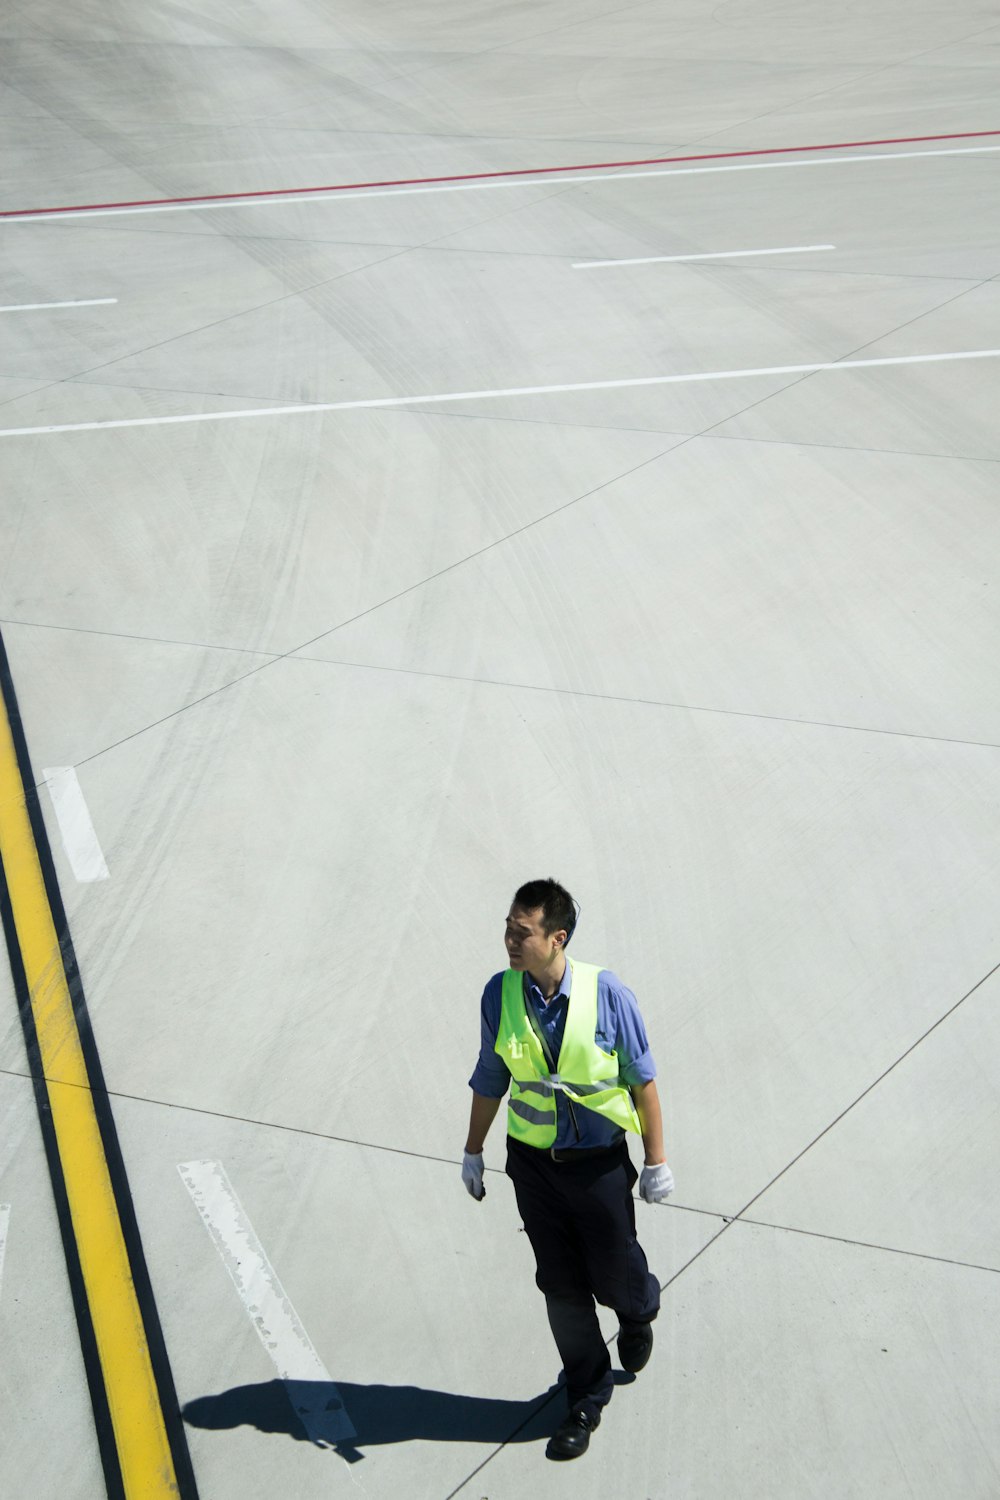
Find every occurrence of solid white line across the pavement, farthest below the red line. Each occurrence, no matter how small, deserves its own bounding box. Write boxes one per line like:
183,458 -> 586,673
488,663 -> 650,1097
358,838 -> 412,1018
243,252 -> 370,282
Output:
0,350 -> 1000,438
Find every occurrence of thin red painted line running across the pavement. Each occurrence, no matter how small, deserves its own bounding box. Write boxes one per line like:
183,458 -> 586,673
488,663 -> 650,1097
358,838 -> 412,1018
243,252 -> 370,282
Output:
0,131 -> 1000,219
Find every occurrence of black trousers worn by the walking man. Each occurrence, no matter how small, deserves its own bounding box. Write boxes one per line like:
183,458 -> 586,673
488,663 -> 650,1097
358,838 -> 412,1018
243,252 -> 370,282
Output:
507,1137 -> 660,1416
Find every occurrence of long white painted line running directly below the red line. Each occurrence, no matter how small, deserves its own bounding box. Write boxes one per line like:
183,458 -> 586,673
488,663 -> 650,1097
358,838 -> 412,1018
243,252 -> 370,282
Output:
7,146 -> 1000,228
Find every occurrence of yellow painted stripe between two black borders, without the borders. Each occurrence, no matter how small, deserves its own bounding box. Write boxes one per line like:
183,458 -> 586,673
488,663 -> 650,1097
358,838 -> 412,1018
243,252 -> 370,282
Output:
0,705 -> 180,1500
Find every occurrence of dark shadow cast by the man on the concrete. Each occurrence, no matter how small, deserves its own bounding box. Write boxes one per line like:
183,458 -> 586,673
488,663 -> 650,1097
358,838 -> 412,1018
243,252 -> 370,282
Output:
181,1371 -> 634,1463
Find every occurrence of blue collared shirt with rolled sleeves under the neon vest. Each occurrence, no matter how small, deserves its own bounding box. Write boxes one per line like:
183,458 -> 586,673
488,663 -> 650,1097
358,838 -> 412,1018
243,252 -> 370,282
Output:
469,962 -> 657,1149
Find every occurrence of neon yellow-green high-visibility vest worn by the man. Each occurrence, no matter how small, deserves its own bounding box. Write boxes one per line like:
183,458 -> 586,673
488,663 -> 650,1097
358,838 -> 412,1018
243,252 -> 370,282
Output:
495,959 -> 640,1149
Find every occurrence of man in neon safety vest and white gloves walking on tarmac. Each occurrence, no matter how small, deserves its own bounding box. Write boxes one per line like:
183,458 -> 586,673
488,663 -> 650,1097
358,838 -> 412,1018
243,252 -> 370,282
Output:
462,881 -> 673,1458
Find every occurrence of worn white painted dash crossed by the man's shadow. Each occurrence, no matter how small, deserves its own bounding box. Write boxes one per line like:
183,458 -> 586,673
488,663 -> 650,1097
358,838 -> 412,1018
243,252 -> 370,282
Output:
177,1161 -> 357,1448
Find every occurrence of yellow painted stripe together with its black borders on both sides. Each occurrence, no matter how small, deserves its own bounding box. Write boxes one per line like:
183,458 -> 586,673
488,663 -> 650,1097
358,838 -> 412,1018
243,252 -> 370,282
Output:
0,638 -> 198,1500
